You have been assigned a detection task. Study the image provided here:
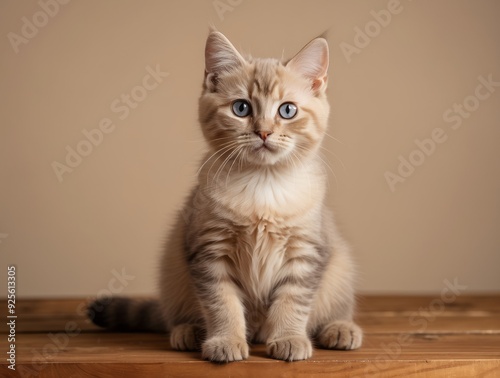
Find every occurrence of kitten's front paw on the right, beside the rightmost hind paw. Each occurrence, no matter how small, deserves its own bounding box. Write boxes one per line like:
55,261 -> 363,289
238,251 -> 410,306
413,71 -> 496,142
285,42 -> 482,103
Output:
266,336 -> 312,361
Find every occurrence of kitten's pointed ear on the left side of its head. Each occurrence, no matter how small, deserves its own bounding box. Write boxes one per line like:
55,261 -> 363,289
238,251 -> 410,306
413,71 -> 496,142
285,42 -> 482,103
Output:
205,31 -> 245,75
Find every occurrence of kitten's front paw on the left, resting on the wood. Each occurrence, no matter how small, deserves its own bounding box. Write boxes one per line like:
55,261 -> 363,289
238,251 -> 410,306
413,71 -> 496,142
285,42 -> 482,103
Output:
202,336 -> 248,362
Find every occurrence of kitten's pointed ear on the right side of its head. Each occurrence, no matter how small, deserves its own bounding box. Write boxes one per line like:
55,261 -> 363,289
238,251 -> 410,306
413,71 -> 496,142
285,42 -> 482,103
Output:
286,38 -> 329,91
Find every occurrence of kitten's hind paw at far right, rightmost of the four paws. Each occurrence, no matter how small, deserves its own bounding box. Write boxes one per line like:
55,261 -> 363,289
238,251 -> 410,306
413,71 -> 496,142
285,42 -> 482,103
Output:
318,321 -> 363,350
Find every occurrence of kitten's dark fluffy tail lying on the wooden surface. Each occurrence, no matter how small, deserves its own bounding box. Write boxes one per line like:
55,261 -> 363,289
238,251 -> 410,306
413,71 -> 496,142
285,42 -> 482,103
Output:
87,297 -> 166,332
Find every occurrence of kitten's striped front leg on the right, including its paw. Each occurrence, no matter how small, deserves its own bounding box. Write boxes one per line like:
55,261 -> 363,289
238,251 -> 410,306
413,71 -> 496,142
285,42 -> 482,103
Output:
265,246 -> 321,361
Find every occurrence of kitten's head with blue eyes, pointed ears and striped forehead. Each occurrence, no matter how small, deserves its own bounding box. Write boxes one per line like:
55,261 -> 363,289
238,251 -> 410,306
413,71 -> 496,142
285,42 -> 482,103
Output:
199,31 -> 329,165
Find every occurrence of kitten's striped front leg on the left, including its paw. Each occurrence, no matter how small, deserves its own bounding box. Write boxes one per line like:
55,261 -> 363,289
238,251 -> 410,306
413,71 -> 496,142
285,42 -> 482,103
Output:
191,253 -> 248,362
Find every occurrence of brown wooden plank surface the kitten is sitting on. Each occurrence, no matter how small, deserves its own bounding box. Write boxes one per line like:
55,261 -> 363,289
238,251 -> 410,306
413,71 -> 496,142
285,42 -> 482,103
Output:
0,295 -> 500,378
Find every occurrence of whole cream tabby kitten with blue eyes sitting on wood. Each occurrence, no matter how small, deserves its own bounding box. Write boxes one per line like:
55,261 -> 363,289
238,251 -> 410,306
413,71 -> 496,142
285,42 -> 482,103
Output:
89,31 -> 362,362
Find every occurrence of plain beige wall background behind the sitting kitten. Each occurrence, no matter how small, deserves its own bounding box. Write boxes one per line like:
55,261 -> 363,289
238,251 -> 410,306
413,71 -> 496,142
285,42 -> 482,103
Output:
0,0 -> 500,297
